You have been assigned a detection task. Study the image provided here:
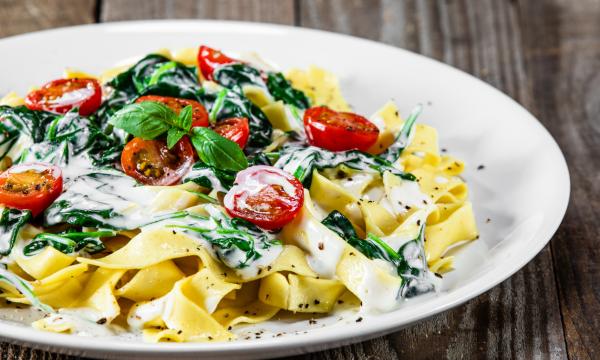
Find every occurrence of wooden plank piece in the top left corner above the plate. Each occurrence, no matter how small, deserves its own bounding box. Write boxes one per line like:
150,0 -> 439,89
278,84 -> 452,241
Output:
0,0 -> 96,37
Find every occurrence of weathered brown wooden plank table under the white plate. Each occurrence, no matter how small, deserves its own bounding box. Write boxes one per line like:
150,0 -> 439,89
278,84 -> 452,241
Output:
0,0 -> 600,359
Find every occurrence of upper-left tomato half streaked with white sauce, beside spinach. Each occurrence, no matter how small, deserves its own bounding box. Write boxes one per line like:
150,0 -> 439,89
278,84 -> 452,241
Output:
25,79 -> 102,116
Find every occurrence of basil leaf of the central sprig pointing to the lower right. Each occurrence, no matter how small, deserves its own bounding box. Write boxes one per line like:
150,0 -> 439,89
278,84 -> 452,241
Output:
191,127 -> 248,171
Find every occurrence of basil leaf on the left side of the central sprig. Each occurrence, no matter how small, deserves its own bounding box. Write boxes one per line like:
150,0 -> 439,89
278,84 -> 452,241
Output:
109,101 -> 177,140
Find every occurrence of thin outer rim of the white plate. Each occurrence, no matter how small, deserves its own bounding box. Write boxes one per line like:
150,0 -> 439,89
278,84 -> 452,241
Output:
0,19 -> 571,356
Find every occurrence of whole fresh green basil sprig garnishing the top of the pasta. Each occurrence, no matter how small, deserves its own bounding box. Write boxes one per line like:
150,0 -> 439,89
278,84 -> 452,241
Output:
109,101 -> 248,171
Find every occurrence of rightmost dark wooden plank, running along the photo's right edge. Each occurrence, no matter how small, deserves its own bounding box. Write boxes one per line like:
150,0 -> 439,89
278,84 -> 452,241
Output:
519,0 -> 600,359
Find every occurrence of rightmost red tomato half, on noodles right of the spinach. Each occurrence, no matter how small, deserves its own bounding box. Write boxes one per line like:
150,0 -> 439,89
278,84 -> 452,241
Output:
304,106 -> 379,151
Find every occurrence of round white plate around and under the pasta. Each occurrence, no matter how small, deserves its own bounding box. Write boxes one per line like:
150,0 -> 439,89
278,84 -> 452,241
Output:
0,21 -> 569,359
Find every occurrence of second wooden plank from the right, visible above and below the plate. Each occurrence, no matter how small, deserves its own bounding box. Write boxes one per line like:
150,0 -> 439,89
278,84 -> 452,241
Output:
300,0 -> 567,359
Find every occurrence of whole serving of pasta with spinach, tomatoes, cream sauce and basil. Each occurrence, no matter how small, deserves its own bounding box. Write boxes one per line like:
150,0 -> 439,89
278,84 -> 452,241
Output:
0,46 -> 478,342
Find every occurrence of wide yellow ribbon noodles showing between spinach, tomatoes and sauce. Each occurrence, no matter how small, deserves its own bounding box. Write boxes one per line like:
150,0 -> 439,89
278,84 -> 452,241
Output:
0,52 -> 478,342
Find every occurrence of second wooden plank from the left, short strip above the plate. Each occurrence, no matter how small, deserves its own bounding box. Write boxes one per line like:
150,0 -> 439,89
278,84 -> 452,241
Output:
100,0 -> 294,25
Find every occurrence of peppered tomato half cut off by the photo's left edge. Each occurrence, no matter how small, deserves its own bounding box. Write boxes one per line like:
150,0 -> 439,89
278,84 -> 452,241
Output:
0,163 -> 63,216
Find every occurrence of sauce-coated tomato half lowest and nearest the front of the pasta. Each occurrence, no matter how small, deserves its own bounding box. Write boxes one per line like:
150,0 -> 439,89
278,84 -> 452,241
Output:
223,165 -> 304,230
